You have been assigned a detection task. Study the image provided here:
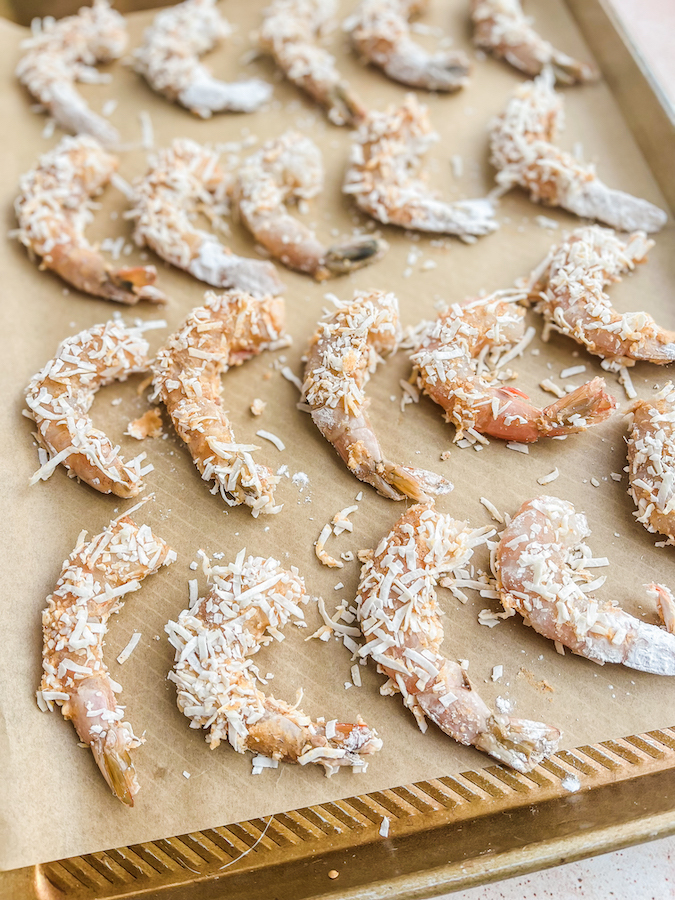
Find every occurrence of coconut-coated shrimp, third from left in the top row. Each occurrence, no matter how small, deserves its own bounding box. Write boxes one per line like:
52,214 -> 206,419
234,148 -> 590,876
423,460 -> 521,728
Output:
259,0 -> 365,125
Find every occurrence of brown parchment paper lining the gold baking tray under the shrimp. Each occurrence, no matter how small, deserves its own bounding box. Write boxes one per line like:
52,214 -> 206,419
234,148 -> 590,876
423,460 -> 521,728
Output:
0,0 -> 675,868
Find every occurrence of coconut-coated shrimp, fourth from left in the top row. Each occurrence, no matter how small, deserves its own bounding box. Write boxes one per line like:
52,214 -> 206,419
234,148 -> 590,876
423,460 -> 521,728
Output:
344,0 -> 471,91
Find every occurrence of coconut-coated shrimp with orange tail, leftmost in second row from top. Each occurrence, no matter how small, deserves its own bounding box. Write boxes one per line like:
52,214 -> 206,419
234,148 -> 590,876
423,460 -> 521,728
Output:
14,135 -> 166,305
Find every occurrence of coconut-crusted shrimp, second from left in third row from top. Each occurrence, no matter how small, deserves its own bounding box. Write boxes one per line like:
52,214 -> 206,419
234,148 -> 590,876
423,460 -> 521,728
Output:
152,291 -> 284,517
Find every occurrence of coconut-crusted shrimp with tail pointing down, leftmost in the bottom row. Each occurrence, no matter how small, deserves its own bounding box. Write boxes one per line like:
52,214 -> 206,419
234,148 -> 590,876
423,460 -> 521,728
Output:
37,515 -> 176,806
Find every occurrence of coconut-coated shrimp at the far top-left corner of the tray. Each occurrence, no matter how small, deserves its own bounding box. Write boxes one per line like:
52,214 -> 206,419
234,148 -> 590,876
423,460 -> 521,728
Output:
16,0 -> 127,146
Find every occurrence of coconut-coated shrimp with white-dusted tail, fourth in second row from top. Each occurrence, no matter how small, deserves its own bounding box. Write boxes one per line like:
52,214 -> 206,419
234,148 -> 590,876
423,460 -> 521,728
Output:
342,94 -> 499,236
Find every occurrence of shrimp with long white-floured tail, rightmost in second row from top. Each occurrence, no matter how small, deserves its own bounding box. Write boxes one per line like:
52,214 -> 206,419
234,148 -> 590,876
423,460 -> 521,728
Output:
490,69 -> 667,232
